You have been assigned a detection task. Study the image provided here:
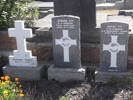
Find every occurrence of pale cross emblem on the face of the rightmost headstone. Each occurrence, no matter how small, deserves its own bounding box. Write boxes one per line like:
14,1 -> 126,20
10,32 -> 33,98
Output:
103,36 -> 126,68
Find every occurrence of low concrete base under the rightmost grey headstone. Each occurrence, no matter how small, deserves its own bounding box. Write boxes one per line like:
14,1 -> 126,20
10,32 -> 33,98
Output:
95,71 -> 133,83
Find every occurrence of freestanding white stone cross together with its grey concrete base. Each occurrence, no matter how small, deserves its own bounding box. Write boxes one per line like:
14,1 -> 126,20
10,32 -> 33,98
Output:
3,20 -> 45,80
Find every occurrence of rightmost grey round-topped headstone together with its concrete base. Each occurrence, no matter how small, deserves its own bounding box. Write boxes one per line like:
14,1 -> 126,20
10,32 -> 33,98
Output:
95,21 -> 132,83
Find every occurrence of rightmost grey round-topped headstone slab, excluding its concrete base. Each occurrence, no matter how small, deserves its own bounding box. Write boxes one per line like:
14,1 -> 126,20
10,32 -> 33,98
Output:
100,22 -> 129,72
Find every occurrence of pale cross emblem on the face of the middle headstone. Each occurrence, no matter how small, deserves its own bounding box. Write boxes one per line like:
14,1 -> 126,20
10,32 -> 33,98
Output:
55,30 -> 77,62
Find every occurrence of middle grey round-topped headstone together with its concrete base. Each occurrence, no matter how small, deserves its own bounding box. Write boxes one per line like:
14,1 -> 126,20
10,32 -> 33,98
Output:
48,15 -> 85,81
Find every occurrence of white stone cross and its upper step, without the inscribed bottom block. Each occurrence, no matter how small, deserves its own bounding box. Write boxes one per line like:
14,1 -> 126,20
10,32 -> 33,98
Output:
9,21 -> 32,58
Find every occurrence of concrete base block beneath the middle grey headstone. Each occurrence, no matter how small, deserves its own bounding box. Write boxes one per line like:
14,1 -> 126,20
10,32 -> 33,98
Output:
48,65 -> 85,82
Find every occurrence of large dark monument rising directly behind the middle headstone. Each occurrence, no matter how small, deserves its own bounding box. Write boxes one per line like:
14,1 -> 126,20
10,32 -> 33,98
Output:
54,0 -> 98,42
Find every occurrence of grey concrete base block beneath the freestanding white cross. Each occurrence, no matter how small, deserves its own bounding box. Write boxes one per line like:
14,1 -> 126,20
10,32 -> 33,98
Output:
3,64 -> 47,80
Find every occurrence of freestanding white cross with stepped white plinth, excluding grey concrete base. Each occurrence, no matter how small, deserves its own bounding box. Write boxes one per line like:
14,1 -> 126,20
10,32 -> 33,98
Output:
8,21 -> 37,67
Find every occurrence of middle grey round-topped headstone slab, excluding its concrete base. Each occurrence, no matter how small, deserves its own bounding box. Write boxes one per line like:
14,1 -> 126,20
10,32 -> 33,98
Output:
52,15 -> 81,68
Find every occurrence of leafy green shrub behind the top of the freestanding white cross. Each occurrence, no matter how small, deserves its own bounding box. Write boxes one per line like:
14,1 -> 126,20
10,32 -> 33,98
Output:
0,0 -> 38,30
